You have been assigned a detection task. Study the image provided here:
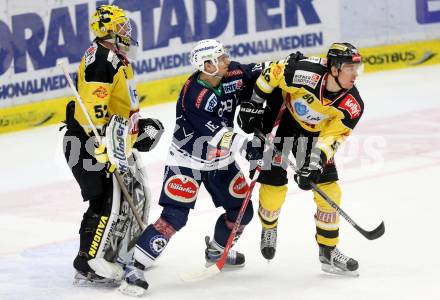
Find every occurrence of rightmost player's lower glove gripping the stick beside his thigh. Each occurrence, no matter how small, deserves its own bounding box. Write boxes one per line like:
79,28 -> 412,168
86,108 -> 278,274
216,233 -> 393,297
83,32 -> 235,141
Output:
294,152 -> 326,191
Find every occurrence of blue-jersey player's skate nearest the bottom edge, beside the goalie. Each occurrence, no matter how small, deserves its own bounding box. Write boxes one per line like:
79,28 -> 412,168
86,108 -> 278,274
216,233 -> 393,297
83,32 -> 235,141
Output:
119,262 -> 148,297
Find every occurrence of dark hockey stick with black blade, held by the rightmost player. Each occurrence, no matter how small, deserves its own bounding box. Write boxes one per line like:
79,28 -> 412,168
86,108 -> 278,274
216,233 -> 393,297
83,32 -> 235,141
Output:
255,129 -> 385,240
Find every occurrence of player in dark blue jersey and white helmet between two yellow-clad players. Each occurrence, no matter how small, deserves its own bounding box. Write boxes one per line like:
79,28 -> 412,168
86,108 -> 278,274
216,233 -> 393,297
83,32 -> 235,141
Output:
117,40 -> 262,295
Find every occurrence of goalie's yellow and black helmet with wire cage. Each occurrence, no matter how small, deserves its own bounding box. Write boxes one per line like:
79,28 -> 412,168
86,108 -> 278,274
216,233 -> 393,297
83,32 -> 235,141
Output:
90,5 -> 137,47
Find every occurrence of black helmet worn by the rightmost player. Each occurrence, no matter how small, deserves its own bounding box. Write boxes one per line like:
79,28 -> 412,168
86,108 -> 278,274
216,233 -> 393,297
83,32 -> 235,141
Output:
327,43 -> 362,70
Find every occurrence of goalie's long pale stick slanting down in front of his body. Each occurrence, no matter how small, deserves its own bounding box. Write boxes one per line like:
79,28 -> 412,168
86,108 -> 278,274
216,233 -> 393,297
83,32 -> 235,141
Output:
58,61 -> 145,230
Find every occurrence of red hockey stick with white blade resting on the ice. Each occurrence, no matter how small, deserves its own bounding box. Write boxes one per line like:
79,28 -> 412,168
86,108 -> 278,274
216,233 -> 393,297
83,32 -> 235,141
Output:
181,102 -> 286,282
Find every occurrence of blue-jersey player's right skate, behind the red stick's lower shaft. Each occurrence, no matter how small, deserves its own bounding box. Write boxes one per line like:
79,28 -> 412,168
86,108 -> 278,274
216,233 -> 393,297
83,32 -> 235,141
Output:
205,236 -> 245,269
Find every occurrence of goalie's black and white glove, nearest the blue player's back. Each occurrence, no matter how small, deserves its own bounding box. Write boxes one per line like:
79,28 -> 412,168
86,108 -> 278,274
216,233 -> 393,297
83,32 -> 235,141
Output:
133,118 -> 164,152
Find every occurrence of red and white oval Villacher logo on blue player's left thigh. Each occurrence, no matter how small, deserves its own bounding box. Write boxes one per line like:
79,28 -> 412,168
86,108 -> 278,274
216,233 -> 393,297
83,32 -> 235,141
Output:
165,174 -> 199,203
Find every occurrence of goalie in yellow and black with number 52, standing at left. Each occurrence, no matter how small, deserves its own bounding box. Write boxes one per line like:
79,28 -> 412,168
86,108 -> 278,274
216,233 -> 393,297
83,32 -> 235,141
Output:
64,5 -> 163,285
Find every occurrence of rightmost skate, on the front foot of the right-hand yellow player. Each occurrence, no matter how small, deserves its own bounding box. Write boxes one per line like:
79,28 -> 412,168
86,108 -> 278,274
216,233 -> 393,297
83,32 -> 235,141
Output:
319,245 -> 359,276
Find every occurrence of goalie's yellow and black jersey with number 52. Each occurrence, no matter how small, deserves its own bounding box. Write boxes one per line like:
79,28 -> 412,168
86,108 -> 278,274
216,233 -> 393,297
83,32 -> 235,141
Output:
75,41 -> 139,143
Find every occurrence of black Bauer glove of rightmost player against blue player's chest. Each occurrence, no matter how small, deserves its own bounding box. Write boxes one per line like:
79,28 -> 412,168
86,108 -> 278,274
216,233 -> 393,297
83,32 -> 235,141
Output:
237,102 -> 264,133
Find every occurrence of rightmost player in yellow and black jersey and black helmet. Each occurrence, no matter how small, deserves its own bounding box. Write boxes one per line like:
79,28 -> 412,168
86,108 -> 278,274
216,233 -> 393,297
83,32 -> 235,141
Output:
238,43 -> 364,275
